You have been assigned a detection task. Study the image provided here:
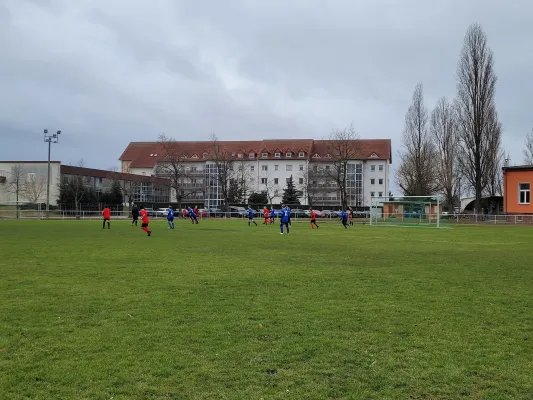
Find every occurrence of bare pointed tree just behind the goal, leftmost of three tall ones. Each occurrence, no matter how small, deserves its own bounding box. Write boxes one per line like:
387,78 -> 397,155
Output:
396,83 -> 441,196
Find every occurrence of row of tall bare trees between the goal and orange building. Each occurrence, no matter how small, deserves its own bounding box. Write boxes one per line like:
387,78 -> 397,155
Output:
396,24 -> 520,211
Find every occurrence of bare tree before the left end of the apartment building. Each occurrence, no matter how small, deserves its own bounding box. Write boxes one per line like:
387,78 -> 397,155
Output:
156,134 -> 199,208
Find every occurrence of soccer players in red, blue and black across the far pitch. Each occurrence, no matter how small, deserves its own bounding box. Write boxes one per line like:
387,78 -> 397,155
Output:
102,205 -> 353,236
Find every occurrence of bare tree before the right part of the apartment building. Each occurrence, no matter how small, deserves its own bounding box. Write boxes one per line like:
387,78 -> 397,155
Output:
321,125 -> 360,209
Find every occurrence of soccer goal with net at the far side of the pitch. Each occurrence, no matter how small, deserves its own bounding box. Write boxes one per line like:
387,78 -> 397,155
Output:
370,196 -> 442,228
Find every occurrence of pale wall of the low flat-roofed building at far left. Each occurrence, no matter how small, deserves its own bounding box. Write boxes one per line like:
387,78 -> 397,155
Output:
0,161 -> 61,205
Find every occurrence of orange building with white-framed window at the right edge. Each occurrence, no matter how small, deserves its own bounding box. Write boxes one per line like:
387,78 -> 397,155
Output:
503,165 -> 533,214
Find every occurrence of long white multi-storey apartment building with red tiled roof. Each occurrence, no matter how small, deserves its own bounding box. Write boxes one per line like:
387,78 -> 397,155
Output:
120,139 -> 392,208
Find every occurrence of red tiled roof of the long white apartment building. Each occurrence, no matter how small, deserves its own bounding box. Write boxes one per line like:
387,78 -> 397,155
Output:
119,139 -> 392,168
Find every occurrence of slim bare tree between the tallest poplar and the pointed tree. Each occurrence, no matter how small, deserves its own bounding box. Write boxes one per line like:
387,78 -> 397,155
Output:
430,97 -> 459,209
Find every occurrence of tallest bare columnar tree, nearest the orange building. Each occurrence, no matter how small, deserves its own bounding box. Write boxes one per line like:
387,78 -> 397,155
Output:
457,24 -> 501,210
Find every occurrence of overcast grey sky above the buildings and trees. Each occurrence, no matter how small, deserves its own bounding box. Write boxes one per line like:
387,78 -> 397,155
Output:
0,0 -> 533,191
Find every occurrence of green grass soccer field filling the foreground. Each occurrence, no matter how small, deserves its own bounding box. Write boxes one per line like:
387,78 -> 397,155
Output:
0,220 -> 533,400
